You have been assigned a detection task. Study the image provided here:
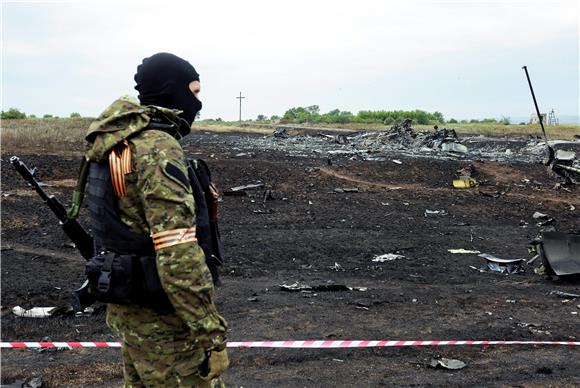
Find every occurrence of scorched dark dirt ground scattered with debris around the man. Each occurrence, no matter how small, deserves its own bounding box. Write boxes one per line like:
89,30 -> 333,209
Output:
1,133 -> 580,387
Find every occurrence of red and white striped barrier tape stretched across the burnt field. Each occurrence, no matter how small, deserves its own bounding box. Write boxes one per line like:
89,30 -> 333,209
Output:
0,340 -> 580,349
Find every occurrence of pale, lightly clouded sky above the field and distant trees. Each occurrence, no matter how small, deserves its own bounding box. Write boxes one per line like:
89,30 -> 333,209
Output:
1,0 -> 580,122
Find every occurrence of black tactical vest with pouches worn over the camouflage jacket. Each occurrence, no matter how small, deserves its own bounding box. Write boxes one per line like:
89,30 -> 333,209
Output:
86,152 -> 223,313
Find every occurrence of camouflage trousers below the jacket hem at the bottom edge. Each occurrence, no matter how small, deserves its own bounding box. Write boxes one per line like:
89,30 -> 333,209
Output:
121,343 -> 225,388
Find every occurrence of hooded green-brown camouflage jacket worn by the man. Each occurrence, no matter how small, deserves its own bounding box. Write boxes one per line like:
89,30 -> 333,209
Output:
85,97 -> 227,353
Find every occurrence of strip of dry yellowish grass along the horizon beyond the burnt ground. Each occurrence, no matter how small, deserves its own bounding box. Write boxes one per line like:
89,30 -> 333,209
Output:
0,119 -> 580,153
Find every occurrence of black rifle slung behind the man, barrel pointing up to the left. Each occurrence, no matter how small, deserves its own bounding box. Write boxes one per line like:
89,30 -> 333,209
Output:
10,156 -> 95,311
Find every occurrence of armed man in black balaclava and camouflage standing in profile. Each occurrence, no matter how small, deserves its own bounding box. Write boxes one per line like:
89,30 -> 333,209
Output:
86,53 -> 228,387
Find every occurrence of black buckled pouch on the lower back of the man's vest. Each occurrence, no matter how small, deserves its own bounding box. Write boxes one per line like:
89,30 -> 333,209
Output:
85,252 -> 137,305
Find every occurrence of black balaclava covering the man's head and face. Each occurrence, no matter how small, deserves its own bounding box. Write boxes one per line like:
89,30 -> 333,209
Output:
135,53 -> 201,131
